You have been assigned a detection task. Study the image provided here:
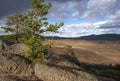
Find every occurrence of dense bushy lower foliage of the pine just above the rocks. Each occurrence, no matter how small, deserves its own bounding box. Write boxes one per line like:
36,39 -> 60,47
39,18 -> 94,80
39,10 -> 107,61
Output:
24,35 -> 53,62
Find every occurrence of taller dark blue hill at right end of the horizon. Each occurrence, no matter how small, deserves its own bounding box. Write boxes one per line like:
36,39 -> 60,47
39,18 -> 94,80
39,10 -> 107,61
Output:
79,34 -> 120,41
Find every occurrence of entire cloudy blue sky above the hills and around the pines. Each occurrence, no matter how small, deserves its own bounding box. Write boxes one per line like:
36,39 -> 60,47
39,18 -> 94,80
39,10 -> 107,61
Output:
0,0 -> 120,37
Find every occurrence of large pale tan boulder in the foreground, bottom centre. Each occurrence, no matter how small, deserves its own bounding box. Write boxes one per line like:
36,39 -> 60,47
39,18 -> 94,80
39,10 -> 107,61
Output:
35,64 -> 98,81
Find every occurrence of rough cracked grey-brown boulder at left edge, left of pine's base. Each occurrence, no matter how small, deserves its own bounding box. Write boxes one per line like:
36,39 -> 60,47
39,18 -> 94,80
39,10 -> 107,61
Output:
0,54 -> 33,77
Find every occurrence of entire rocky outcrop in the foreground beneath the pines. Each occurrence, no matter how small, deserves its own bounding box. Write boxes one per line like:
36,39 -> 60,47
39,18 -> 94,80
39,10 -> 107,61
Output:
0,42 -> 115,81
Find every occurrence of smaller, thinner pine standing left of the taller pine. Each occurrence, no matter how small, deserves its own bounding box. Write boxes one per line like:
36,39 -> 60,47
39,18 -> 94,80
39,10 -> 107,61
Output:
2,13 -> 24,42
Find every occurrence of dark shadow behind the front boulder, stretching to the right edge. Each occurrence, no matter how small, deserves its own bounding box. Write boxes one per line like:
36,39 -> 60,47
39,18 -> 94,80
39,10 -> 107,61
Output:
47,55 -> 120,81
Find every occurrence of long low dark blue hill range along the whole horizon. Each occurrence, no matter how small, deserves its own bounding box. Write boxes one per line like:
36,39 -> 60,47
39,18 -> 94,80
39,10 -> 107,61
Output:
47,34 -> 120,41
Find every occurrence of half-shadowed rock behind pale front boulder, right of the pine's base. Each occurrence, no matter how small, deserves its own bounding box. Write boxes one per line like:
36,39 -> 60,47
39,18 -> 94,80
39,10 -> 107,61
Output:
47,55 -> 80,69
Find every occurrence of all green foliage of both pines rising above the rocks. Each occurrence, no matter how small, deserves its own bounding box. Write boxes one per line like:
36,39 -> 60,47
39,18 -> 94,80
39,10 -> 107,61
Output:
2,0 -> 63,61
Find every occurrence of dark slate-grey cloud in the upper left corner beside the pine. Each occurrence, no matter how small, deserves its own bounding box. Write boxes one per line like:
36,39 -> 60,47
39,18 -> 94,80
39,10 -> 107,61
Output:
0,0 -> 30,19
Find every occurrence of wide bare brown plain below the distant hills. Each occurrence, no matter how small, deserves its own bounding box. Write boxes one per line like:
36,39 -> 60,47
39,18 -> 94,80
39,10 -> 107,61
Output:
47,39 -> 120,64
